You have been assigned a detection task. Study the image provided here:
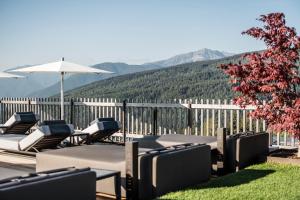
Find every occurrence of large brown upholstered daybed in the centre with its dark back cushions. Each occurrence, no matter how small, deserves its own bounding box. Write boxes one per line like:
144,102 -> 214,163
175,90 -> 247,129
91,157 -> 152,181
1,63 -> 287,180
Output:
36,143 -> 211,199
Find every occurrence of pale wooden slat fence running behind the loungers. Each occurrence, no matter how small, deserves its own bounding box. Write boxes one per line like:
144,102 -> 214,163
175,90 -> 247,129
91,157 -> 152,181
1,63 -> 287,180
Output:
0,98 -> 298,147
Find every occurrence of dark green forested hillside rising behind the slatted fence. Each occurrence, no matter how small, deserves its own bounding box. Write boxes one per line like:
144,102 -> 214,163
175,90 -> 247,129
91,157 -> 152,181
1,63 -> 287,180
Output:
66,55 -> 241,100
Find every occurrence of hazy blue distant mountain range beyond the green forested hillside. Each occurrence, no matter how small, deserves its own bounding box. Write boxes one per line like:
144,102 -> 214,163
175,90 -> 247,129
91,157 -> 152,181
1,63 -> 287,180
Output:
0,48 -> 234,97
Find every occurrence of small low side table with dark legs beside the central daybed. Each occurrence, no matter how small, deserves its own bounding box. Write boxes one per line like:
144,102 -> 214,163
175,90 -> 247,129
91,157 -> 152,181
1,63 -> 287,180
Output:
91,168 -> 121,200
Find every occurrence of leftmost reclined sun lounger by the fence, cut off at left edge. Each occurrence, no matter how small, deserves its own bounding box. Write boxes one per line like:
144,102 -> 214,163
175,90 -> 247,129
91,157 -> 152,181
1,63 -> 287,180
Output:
0,112 -> 40,134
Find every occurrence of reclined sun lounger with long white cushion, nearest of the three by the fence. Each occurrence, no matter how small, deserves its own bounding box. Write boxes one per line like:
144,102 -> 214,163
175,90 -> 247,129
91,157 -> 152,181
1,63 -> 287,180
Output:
0,121 -> 74,152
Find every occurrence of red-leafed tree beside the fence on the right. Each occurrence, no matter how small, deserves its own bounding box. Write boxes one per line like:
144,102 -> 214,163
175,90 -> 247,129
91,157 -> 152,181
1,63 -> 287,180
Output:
221,13 -> 300,142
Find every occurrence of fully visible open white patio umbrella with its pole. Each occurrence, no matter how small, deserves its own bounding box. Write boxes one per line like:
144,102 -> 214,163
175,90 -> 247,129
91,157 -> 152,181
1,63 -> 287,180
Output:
12,58 -> 113,119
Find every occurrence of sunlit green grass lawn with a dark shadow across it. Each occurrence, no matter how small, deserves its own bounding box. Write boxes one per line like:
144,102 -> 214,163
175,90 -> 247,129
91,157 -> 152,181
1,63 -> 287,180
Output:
160,163 -> 300,200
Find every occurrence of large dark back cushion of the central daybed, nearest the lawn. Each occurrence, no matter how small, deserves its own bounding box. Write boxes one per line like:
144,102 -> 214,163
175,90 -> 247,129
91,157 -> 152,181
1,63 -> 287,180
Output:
152,145 -> 211,197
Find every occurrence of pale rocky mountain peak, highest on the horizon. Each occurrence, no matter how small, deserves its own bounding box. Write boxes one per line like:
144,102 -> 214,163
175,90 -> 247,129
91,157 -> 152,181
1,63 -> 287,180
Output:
146,48 -> 234,67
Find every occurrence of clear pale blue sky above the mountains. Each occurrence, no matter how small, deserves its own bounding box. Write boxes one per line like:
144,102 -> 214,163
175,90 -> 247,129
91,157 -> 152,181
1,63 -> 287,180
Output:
0,0 -> 300,70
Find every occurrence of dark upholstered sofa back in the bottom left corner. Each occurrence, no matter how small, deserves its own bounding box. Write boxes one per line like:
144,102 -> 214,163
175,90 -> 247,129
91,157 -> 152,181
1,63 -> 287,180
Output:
0,168 -> 96,200
